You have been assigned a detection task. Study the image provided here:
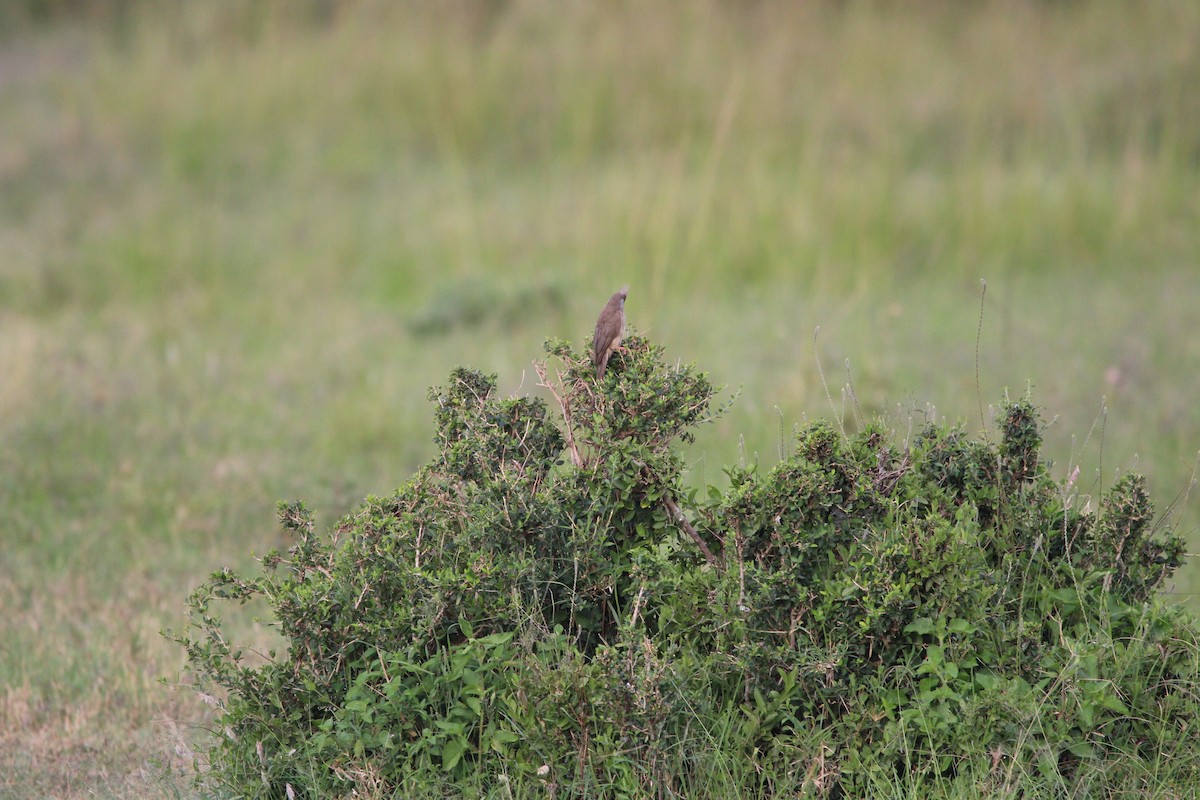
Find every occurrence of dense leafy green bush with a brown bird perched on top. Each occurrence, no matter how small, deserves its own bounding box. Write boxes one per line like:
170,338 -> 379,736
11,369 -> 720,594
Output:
170,336 -> 1200,798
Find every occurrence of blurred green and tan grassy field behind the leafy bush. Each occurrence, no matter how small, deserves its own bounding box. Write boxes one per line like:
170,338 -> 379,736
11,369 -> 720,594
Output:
0,0 -> 1200,798
